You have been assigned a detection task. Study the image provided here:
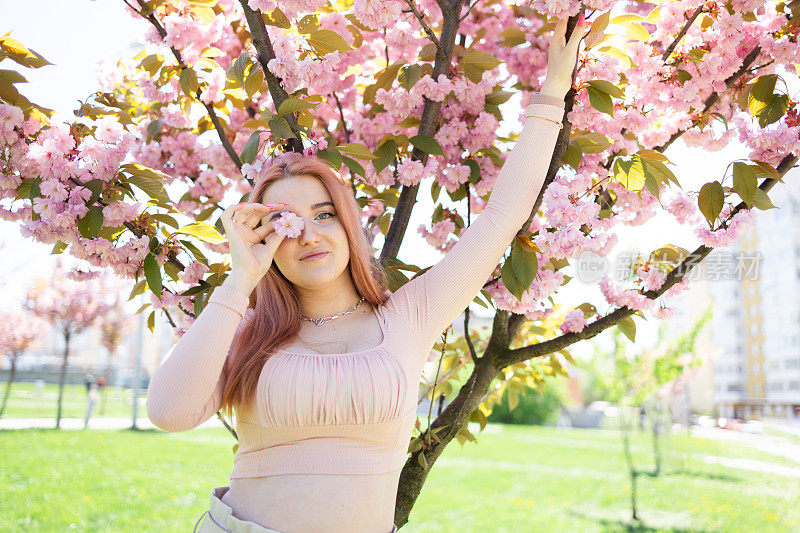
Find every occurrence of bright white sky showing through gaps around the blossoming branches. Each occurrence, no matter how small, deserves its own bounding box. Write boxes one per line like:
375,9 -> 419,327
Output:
0,0 -> 797,354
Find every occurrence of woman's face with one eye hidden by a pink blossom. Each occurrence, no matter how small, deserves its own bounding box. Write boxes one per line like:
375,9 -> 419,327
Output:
260,175 -> 350,289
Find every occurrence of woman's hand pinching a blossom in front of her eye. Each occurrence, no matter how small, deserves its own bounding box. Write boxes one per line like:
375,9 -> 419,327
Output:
220,202 -> 287,296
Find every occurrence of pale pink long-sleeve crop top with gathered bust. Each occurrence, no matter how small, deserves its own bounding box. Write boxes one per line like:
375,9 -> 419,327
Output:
147,93 -> 565,479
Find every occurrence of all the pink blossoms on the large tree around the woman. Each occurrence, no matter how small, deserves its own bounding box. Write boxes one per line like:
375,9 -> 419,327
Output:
0,0 -> 800,331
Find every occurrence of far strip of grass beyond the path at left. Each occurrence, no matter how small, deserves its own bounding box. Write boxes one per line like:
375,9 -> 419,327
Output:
0,382 -> 147,420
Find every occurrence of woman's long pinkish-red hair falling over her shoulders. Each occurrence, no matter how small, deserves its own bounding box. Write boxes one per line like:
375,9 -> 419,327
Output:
221,152 -> 391,419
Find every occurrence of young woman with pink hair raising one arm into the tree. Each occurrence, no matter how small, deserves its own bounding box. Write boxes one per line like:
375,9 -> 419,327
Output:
147,15 -> 585,533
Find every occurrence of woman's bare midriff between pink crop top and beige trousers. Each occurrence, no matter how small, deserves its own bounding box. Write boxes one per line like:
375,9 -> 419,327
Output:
222,469 -> 401,533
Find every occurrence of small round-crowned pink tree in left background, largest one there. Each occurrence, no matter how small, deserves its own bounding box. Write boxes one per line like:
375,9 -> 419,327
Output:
24,261 -> 113,428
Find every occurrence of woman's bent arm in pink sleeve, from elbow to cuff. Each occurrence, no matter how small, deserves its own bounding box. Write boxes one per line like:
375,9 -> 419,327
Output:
147,278 -> 249,431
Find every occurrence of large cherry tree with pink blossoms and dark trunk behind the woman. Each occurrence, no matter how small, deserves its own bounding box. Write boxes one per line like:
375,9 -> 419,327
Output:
0,0 -> 800,525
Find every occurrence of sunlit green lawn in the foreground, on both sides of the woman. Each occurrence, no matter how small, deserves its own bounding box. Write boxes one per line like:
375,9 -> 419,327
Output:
0,425 -> 800,533
